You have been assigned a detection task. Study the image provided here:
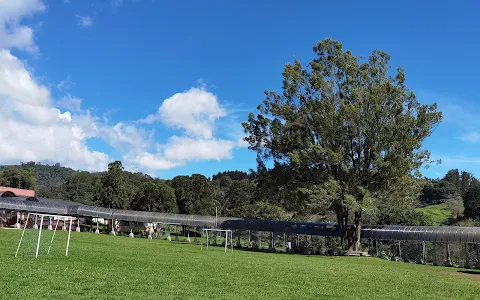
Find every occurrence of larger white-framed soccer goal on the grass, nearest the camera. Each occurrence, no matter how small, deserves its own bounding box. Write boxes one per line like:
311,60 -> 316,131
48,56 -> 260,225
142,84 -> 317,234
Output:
15,213 -> 76,257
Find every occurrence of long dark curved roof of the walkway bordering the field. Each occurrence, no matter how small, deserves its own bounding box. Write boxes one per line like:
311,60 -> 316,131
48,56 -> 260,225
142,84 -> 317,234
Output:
0,197 -> 480,244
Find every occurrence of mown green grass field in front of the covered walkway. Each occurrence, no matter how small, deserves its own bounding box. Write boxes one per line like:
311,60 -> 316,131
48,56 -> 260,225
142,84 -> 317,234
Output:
0,229 -> 480,300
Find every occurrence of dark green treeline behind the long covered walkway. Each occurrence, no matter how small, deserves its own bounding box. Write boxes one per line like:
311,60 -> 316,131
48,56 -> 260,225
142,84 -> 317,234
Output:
0,161 -> 480,225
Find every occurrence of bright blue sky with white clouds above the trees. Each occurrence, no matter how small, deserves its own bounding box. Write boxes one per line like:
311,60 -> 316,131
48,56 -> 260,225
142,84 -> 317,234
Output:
0,0 -> 480,178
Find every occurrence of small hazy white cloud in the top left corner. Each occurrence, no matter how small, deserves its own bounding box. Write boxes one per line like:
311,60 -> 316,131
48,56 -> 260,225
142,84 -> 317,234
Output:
0,0 -> 45,52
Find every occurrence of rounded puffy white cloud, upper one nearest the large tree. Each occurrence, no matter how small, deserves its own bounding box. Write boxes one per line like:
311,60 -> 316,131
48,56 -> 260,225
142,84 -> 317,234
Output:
142,88 -> 227,138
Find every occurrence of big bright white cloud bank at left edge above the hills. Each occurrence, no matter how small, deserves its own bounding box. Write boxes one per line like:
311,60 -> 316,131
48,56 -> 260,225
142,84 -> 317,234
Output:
0,50 -> 109,170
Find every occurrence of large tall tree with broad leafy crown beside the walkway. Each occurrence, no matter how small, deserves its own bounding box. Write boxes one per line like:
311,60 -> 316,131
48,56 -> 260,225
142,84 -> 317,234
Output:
243,39 -> 441,250
